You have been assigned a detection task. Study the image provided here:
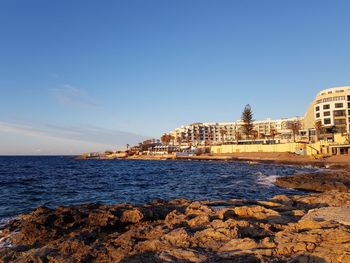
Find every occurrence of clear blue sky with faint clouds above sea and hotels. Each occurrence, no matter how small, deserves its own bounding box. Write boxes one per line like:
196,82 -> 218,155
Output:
0,0 -> 350,154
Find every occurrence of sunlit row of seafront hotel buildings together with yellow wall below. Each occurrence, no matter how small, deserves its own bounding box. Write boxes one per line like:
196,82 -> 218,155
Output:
152,86 -> 350,155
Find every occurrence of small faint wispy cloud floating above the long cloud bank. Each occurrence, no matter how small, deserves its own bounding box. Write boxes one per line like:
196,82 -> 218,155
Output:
52,84 -> 97,107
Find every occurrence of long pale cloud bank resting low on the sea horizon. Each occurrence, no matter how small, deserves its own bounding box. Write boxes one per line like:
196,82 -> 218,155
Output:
0,121 -> 146,154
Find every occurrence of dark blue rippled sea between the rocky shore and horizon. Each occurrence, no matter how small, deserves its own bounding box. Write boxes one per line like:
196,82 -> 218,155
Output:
0,156 -> 315,219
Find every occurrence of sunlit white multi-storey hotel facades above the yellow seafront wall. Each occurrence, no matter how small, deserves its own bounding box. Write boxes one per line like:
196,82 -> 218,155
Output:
166,86 -> 350,145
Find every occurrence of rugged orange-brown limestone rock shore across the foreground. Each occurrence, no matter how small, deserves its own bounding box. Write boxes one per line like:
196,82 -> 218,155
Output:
0,191 -> 350,263
